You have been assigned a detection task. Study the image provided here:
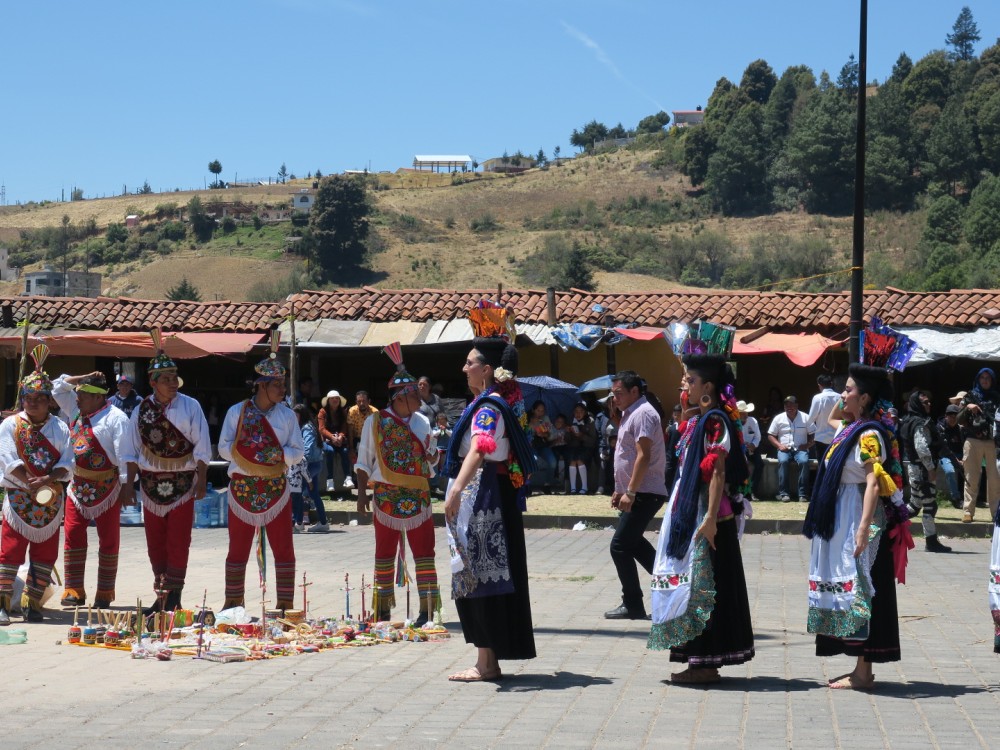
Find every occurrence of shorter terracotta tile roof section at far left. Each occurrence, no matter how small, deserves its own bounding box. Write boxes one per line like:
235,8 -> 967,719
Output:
0,297 -> 276,333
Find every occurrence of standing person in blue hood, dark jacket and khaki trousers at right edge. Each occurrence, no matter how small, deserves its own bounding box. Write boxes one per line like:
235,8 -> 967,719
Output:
958,367 -> 1000,523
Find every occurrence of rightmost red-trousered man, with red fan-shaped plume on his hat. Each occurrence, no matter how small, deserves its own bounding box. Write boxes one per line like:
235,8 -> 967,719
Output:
354,343 -> 441,627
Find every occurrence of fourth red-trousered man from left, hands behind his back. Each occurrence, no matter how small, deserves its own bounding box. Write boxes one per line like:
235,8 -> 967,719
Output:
219,340 -> 305,610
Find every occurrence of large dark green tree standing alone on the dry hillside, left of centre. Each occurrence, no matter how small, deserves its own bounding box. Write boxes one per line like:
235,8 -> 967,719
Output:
309,175 -> 371,282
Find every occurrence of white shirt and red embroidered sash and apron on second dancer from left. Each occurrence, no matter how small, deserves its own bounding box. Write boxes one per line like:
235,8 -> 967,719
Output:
52,375 -> 129,520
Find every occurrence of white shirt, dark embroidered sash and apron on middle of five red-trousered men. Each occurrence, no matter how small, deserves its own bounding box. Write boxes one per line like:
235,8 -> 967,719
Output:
121,393 -> 212,516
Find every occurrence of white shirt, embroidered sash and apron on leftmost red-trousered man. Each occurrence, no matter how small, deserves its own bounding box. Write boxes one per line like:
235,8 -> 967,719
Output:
0,411 -> 73,542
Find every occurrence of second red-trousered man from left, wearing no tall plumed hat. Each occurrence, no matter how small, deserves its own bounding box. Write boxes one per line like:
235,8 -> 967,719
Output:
52,372 -> 129,609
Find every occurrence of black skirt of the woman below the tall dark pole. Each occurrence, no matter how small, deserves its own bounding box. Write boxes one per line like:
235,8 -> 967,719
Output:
816,534 -> 901,663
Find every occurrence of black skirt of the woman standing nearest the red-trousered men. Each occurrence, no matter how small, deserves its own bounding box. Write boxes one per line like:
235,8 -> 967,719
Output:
455,474 -> 535,659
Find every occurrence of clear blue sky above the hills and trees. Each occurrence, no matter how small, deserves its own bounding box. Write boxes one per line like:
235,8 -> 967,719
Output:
0,0 -> 1000,204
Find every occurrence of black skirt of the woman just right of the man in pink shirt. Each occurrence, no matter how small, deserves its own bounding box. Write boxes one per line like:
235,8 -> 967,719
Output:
670,518 -> 754,668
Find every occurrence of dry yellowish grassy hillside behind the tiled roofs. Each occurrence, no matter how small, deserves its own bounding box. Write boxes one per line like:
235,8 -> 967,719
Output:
0,149 -> 922,300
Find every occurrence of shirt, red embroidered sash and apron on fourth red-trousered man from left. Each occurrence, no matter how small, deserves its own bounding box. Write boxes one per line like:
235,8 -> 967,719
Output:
219,399 -> 305,526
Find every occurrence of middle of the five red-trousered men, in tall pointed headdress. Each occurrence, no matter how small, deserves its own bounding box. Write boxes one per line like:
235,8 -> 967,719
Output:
121,330 -> 212,614
